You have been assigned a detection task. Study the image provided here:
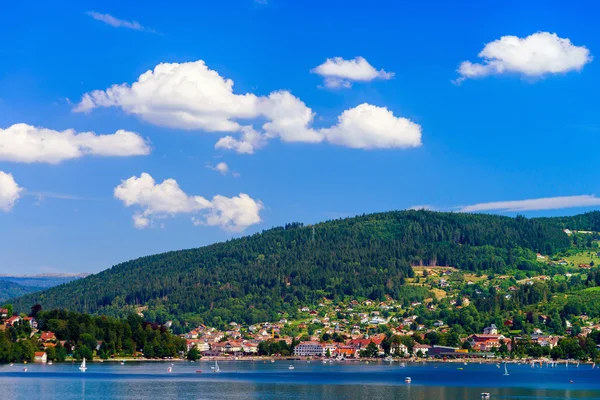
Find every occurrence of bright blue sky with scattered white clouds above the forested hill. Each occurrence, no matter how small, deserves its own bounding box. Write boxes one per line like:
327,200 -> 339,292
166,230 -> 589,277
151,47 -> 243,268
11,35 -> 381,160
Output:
0,0 -> 600,274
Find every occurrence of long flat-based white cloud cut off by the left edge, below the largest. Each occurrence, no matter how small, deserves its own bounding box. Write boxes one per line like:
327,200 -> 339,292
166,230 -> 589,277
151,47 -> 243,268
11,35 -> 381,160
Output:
0,124 -> 150,164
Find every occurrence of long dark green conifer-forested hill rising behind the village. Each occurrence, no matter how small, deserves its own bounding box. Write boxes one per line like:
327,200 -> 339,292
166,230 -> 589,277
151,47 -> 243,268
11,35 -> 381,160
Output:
14,211 -> 570,325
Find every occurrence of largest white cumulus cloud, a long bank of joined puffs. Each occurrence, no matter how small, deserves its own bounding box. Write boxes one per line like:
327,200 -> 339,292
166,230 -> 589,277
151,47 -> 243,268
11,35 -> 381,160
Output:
75,60 -> 420,154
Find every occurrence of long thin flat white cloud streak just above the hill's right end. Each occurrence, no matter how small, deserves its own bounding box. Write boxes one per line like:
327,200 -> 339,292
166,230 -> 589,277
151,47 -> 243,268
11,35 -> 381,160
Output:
458,195 -> 600,212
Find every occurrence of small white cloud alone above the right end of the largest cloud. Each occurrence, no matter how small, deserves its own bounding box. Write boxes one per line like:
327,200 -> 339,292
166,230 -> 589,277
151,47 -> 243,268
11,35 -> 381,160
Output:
311,57 -> 394,88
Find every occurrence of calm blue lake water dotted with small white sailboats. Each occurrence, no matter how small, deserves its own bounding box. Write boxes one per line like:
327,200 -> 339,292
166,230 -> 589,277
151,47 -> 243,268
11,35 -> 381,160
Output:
0,361 -> 600,400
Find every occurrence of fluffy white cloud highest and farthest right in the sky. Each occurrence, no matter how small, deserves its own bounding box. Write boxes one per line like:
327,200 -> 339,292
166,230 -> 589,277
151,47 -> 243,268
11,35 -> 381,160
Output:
456,32 -> 592,82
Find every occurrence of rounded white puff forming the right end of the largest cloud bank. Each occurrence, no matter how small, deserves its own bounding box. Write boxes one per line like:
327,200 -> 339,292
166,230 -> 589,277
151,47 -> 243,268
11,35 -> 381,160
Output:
321,103 -> 421,149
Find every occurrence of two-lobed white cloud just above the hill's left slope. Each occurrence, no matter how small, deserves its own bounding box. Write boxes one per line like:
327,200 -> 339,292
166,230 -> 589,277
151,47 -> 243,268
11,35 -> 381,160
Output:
114,172 -> 263,232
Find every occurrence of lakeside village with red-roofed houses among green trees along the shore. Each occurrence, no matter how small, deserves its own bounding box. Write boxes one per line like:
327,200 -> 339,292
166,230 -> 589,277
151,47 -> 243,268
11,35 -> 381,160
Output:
0,230 -> 600,362
